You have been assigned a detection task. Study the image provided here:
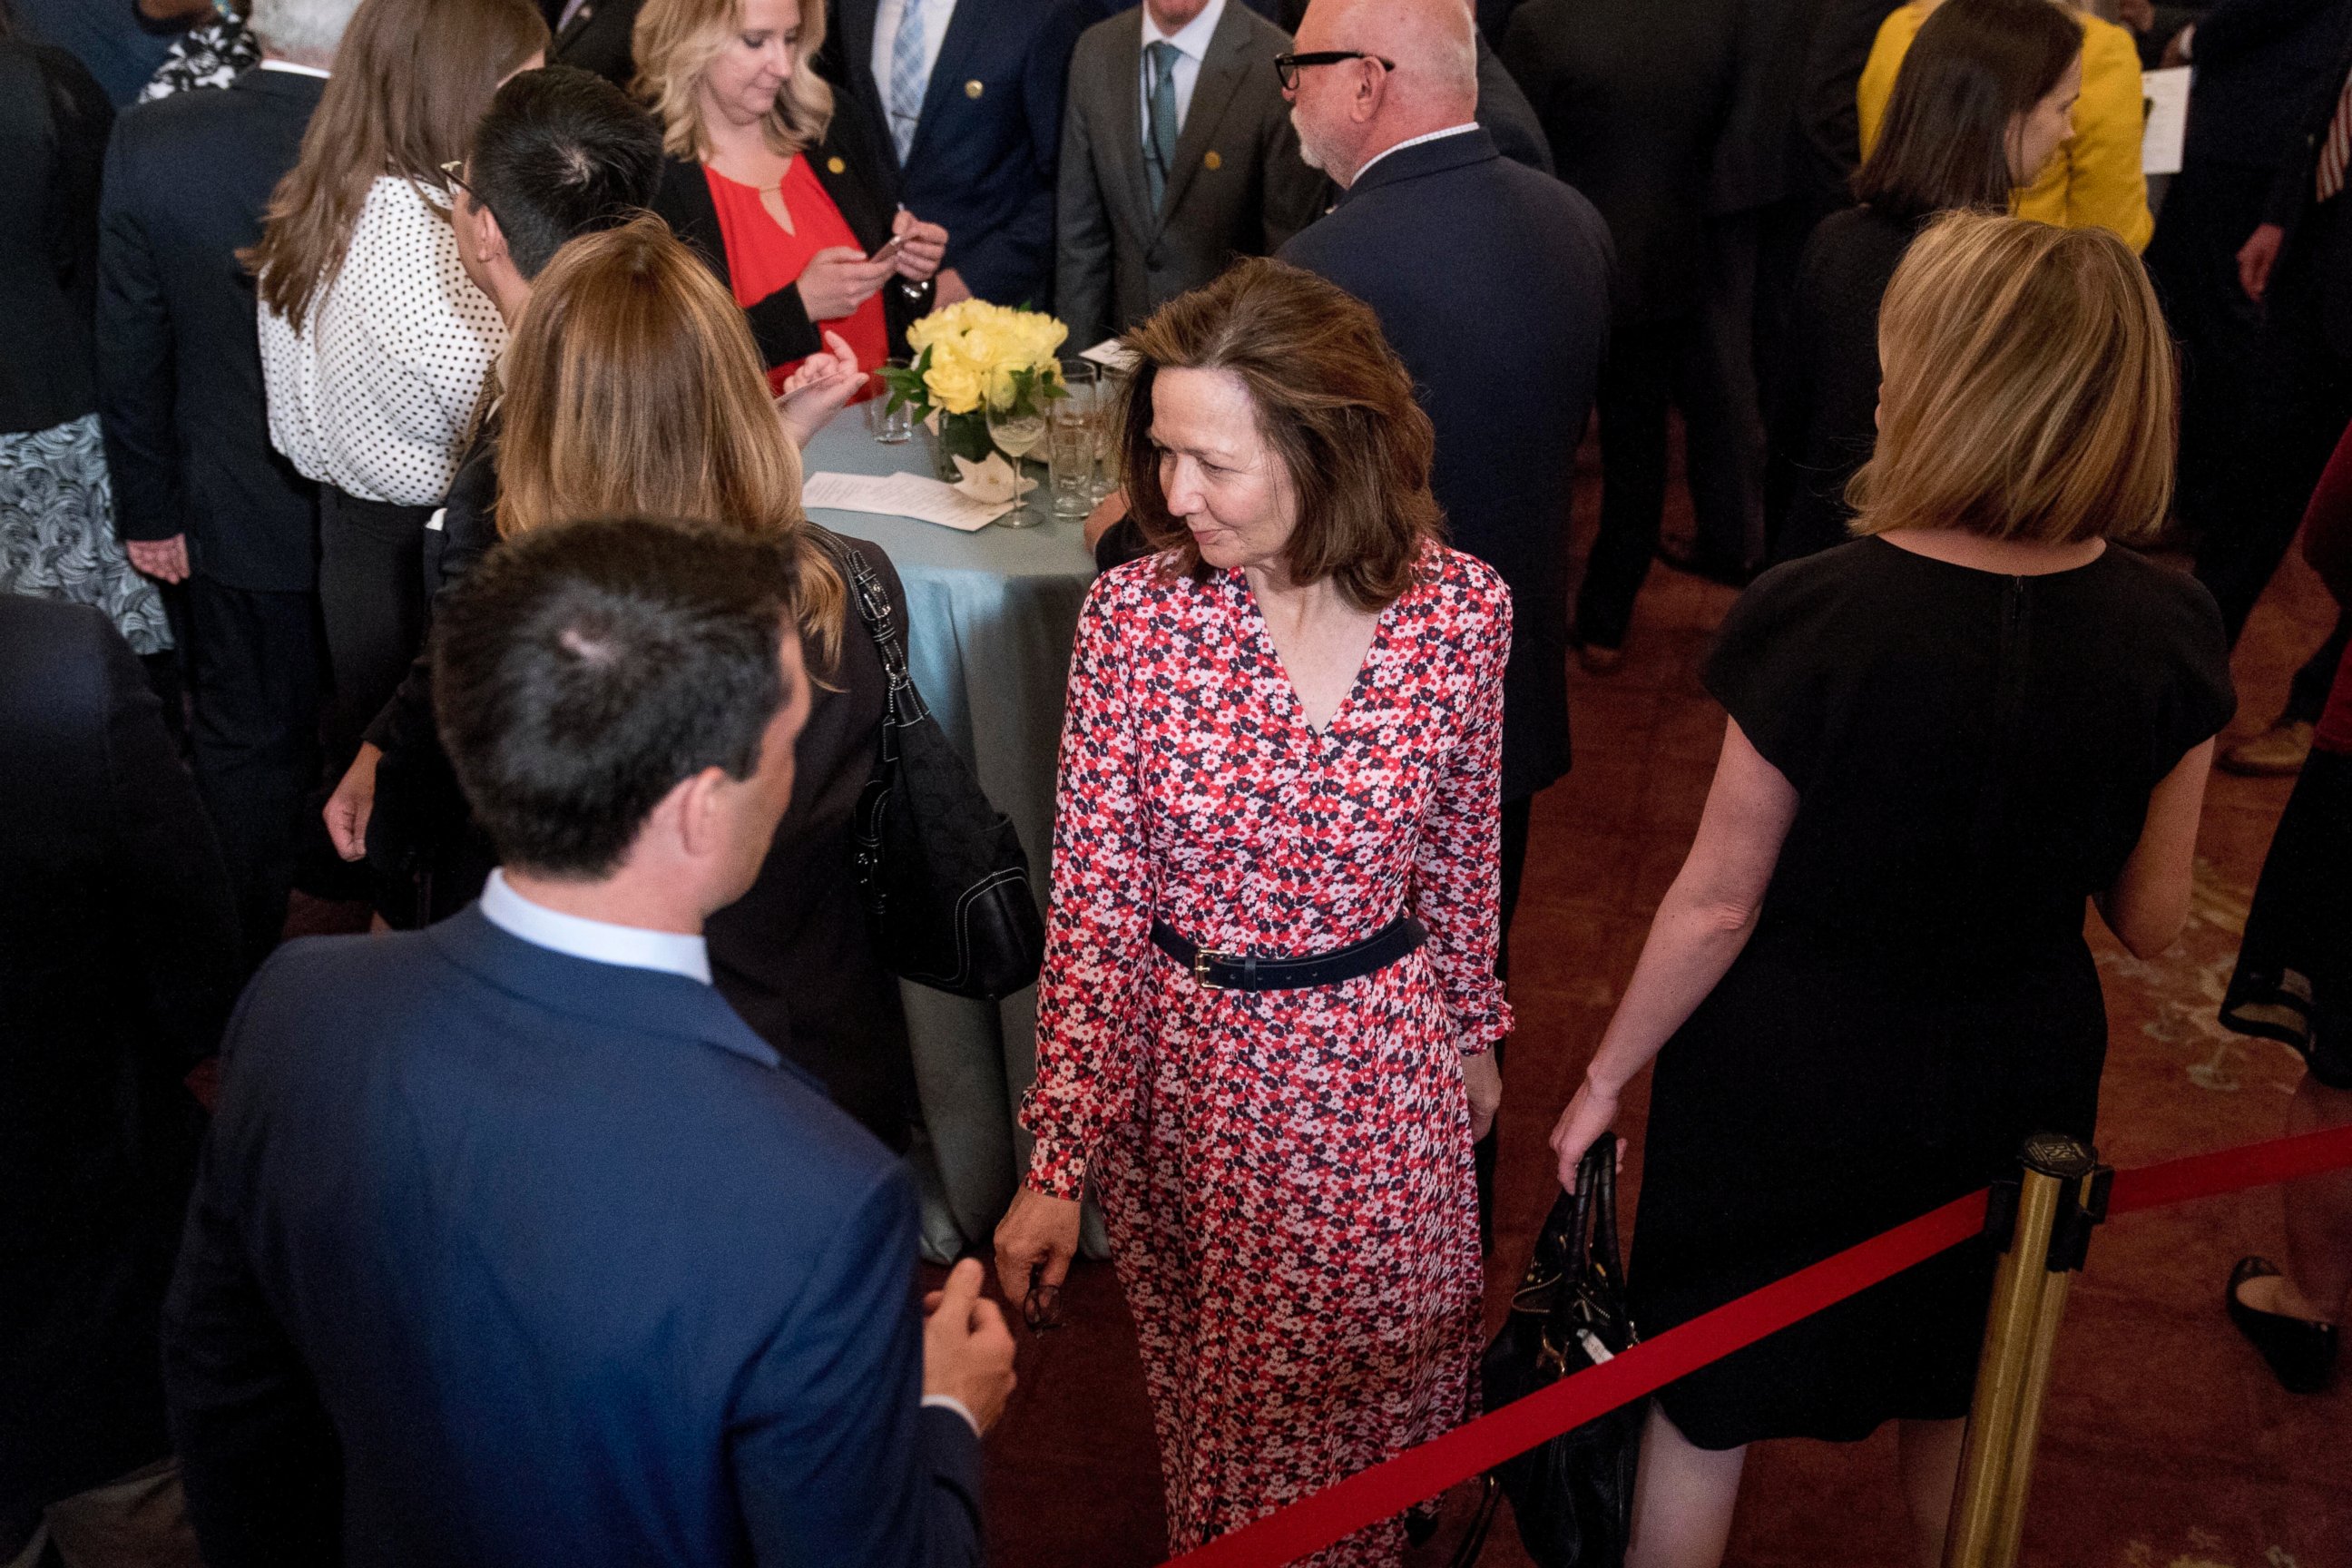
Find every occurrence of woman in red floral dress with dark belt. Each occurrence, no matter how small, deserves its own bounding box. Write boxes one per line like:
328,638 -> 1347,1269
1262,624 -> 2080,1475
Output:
997,261 -> 1510,1563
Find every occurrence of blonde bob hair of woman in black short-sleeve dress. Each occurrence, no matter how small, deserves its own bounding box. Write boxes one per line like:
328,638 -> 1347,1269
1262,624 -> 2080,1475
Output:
1847,211 -> 2176,545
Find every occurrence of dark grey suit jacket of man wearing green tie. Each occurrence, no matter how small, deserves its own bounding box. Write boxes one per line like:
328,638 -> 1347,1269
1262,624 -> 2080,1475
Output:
1054,5 -> 1328,348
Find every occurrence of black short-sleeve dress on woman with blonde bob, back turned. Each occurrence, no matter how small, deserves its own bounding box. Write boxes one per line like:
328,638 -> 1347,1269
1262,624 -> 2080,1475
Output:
1630,538 -> 2234,1448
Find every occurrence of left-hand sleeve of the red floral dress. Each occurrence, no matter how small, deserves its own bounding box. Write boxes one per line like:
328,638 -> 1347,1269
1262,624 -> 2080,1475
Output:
1021,566 -> 1160,1199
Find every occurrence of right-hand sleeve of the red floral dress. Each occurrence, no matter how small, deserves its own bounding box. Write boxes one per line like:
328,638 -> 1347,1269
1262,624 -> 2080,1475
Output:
1414,557 -> 1510,1055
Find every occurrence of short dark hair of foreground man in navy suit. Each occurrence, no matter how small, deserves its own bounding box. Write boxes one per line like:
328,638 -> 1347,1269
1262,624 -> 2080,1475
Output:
433,517 -> 798,879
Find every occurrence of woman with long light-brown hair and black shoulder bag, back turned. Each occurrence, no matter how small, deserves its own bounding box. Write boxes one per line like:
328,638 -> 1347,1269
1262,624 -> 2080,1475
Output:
365,216 -> 915,1150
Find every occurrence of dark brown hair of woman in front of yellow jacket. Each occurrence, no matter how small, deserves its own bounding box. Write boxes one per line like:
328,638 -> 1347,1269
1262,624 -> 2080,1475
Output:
1853,0 -> 2082,221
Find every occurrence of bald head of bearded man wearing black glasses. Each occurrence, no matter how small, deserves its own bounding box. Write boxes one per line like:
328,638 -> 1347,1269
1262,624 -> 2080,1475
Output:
1291,0 -> 1477,186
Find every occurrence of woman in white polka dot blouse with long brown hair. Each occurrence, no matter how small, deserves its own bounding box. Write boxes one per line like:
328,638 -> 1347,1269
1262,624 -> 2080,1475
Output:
245,0 -> 548,771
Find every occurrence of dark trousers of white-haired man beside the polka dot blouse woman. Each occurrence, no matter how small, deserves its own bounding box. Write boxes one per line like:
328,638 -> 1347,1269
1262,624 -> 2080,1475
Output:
186,576 -> 325,968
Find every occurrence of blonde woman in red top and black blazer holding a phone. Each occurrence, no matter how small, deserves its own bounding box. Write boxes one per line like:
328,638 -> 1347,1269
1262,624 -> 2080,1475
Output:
632,0 -> 957,393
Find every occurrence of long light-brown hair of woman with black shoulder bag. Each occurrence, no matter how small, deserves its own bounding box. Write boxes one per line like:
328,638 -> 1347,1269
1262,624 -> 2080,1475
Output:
496,214 -> 847,670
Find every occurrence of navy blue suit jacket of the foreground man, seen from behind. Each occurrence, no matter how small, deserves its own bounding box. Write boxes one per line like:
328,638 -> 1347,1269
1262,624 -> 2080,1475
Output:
164,910 -> 981,1568
